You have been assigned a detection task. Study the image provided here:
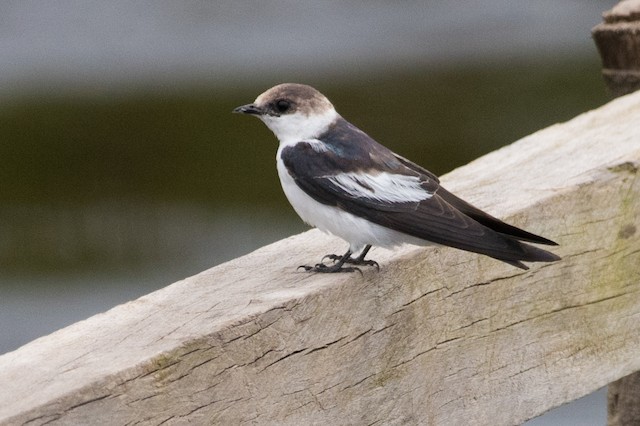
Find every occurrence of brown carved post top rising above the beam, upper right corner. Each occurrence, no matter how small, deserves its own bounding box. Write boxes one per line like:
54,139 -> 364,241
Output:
592,0 -> 640,96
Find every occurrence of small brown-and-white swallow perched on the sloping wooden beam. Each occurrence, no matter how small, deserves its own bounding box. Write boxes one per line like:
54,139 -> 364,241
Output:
233,83 -> 560,273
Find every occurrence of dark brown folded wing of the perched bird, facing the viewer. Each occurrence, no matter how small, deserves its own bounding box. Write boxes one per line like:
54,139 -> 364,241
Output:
281,143 -> 557,268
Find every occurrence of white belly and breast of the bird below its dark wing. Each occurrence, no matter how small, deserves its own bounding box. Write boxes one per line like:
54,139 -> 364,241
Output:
277,155 -> 428,253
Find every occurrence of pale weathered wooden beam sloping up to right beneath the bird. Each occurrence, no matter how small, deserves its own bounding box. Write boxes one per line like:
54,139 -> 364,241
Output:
0,93 -> 640,425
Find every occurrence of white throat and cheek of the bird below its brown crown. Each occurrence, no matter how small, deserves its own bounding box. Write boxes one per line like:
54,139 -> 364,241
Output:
260,108 -> 339,145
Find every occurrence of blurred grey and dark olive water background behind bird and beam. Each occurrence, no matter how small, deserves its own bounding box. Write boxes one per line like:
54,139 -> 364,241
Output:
0,0 -> 616,425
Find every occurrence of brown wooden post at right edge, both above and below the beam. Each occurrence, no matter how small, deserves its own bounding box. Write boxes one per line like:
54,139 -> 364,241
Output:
593,0 -> 640,426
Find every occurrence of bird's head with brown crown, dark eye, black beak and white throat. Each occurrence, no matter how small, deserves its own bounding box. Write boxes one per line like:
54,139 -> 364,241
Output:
233,83 -> 339,143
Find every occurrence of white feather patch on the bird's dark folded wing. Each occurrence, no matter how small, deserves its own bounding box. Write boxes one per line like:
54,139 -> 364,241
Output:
329,172 -> 433,203
